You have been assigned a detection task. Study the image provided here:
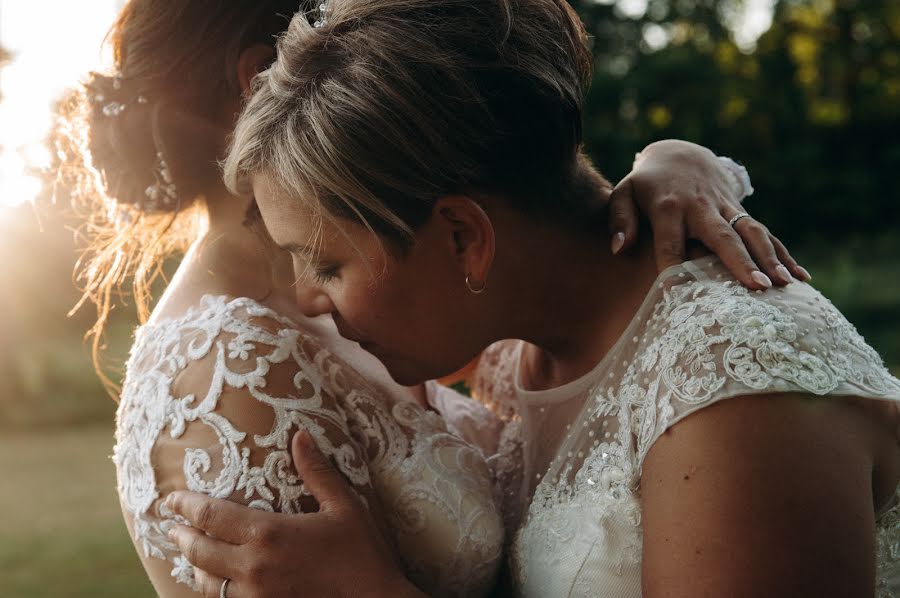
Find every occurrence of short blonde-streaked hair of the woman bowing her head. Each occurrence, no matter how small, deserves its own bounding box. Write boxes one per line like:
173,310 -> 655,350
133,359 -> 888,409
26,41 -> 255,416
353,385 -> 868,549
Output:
224,0 -> 608,252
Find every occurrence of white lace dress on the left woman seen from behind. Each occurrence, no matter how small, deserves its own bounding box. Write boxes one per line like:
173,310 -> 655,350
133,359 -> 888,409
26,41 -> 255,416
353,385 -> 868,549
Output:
114,296 -> 503,596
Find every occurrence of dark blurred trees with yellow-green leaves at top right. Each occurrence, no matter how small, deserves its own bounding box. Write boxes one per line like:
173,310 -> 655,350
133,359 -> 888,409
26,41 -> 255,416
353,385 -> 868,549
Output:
576,0 -> 900,239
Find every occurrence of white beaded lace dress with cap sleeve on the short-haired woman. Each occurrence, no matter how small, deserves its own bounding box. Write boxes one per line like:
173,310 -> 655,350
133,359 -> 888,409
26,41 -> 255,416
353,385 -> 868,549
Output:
473,257 -> 900,598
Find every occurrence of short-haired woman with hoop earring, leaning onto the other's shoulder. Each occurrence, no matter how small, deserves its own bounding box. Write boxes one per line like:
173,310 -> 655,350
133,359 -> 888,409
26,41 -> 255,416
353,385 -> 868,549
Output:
170,0 -> 900,598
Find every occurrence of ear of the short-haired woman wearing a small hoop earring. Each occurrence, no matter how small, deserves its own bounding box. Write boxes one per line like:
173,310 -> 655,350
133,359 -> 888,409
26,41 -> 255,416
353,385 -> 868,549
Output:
432,195 -> 496,290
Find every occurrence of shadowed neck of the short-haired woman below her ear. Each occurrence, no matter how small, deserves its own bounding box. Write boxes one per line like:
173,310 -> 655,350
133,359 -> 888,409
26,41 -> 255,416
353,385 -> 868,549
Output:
488,209 -> 657,387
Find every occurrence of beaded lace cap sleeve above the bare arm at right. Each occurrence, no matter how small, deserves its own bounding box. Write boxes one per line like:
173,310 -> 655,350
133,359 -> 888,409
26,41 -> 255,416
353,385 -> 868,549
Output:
635,261 -> 900,462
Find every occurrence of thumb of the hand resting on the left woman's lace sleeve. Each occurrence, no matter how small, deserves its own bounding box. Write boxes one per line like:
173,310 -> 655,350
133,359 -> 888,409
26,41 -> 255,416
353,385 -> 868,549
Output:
291,430 -> 356,511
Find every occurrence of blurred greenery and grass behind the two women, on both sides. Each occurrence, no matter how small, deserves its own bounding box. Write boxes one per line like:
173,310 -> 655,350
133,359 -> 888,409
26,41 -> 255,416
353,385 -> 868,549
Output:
0,0 -> 900,598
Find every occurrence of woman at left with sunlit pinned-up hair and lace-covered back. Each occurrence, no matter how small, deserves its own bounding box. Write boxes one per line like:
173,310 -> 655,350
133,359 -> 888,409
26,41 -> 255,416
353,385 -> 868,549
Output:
60,0 -> 803,596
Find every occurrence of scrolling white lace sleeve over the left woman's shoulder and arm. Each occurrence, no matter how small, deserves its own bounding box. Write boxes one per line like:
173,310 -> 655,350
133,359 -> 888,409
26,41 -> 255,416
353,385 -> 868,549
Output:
114,300 -> 373,587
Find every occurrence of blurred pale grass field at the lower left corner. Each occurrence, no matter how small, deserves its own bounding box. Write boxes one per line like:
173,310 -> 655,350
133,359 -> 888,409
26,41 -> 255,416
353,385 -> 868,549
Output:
0,426 -> 155,598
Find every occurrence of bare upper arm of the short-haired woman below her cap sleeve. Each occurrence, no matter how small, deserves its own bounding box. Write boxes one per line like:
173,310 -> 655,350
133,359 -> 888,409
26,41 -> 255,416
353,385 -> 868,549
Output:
641,394 -> 900,597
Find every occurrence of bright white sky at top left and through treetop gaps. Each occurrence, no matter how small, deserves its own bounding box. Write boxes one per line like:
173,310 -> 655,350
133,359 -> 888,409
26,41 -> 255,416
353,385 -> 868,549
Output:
0,0 -> 775,216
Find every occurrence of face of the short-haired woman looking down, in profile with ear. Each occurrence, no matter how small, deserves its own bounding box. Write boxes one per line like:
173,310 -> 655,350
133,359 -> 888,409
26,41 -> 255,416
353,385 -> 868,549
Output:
253,177 -> 481,385
